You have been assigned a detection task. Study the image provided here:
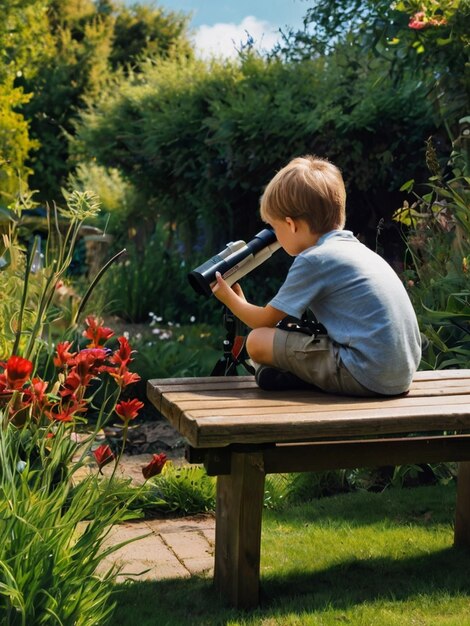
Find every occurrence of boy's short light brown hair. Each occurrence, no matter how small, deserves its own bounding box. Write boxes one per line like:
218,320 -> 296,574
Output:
260,155 -> 346,234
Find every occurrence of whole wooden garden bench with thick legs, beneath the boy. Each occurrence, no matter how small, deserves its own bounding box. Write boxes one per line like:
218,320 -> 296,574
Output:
148,370 -> 470,608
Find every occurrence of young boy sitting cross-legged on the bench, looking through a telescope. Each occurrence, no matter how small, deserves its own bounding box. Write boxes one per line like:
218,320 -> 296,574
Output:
213,156 -> 421,396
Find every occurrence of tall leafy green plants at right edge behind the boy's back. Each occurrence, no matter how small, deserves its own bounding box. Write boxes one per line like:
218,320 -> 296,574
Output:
395,132 -> 470,369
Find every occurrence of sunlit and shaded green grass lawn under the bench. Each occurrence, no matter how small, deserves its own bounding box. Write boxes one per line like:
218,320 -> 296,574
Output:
112,486 -> 470,626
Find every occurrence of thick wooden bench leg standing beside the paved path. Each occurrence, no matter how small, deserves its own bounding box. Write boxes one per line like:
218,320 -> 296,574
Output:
214,452 -> 265,609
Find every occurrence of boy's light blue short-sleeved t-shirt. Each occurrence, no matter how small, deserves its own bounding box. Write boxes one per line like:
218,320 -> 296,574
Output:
269,230 -> 421,395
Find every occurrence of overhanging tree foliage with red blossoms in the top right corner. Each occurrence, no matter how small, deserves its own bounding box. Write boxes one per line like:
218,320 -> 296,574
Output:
275,0 -> 470,127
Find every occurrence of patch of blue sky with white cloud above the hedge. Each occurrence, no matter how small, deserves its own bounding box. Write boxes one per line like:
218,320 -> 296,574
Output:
126,0 -> 312,58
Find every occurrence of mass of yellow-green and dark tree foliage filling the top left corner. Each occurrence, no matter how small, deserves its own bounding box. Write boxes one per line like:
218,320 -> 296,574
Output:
0,0 -> 191,200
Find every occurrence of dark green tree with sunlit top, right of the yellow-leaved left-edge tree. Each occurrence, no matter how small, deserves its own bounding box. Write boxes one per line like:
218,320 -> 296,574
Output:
13,0 -> 190,201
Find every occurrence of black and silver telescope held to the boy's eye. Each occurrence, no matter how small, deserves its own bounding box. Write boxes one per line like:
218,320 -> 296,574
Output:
188,228 -> 281,296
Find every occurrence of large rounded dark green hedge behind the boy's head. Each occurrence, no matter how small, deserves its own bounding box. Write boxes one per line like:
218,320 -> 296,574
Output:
78,52 -> 432,258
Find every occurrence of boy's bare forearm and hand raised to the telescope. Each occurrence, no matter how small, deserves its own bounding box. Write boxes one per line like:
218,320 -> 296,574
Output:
212,272 -> 286,328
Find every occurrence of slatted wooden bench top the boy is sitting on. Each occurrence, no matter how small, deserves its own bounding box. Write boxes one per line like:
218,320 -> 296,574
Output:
147,369 -> 470,448
